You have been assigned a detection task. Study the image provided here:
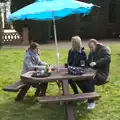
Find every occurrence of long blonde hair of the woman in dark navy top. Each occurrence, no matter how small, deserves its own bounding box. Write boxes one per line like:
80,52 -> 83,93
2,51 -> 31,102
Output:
71,36 -> 82,52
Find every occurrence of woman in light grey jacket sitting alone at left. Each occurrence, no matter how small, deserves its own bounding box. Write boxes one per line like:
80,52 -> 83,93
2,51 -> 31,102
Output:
16,42 -> 48,101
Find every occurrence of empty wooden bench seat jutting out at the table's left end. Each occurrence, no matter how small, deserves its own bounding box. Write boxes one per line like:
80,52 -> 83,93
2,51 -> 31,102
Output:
3,80 -> 26,92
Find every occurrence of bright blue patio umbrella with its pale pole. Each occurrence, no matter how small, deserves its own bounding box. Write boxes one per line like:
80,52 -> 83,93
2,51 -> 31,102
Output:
7,0 -> 94,69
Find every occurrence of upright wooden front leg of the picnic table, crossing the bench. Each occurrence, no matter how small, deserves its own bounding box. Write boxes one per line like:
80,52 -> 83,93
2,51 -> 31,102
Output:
62,80 -> 75,120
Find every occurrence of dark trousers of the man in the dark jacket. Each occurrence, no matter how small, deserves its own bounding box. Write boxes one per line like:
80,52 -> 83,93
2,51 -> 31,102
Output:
76,80 -> 95,103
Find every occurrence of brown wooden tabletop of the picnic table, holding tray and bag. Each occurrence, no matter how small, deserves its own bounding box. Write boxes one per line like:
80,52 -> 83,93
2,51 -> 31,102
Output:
21,68 -> 96,83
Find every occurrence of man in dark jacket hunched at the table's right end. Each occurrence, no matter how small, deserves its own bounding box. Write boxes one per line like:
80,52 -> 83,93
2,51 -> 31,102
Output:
76,39 -> 111,109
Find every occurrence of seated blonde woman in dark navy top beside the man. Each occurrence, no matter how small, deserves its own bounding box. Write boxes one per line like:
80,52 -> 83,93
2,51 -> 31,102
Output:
67,36 -> 87,94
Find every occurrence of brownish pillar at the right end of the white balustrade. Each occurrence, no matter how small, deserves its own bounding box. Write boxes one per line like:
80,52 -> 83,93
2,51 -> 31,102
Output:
22,27 -> 29,45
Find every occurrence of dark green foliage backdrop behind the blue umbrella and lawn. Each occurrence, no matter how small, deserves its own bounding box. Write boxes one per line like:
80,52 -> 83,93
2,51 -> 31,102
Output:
11,0 -> 120,40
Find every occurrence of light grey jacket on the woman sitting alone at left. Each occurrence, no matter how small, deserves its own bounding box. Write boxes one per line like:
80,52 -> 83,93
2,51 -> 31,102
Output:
21,50 -> 46,74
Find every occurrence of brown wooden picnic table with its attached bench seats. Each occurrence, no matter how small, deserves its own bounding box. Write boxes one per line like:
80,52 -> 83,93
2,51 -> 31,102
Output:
3,68 -> 100,120
